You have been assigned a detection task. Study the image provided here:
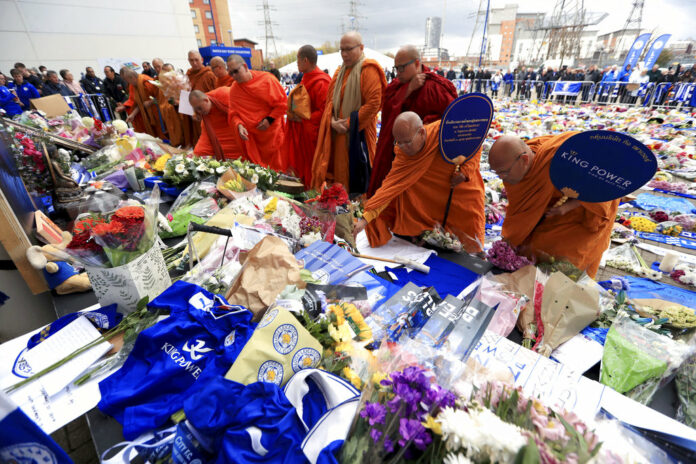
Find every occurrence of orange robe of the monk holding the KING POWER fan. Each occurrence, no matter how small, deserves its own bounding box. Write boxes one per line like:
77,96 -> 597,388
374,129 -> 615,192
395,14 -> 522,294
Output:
503,132 -> 619,278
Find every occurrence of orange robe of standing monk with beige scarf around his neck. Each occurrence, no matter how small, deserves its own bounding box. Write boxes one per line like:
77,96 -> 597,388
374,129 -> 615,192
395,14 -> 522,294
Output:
311,59 -> 387,189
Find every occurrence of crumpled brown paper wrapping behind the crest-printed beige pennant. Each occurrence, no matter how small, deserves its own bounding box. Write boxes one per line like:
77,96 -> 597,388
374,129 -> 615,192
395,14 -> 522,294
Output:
225,236 -> 305,322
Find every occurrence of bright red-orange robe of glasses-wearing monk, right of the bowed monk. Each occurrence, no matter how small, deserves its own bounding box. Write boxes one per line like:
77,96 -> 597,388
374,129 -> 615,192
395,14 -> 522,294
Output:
228,71 -> 288,169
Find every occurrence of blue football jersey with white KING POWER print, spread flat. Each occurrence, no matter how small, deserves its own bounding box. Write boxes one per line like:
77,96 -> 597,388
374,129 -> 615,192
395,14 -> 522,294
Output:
98,281 -> 256,439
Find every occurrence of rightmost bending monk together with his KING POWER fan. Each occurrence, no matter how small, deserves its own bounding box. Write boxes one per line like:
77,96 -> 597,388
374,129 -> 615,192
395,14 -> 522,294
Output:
488,131 -> 657,278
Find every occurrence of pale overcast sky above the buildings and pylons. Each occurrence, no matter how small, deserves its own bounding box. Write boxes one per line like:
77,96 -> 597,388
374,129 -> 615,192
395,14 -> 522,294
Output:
223,0 -> 696,56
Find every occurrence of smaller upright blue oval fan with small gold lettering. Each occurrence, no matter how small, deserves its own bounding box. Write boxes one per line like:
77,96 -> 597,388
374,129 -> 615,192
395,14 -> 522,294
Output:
440,93 -> 493,164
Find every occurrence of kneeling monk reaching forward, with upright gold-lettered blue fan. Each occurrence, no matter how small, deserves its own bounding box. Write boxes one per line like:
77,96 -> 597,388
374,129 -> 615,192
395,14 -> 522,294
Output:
355,94 -> 493,253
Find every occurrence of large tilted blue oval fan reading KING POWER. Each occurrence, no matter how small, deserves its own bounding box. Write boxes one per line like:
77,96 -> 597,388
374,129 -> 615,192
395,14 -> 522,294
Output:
549,130 -> 657,203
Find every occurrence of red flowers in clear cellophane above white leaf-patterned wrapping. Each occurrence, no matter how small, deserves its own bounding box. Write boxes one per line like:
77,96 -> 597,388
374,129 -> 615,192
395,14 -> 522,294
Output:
60,183 -> 159,268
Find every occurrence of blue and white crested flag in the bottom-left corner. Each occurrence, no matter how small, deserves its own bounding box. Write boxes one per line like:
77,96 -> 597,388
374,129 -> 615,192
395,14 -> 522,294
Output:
0,390 -> 73,464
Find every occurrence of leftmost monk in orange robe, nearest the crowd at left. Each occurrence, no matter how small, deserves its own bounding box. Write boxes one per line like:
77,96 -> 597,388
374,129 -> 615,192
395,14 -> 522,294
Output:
116,67 -> 164,138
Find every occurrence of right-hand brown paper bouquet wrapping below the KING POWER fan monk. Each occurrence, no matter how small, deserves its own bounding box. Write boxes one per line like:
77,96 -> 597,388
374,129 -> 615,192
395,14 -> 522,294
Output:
539,272 -> 600,357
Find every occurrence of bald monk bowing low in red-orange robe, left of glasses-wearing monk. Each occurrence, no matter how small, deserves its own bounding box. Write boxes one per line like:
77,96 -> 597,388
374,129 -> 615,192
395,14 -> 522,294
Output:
189,87 -> 244,160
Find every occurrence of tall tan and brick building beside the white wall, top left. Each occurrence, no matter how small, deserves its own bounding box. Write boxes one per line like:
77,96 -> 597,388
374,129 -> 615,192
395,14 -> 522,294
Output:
189,0 -> 233,47
